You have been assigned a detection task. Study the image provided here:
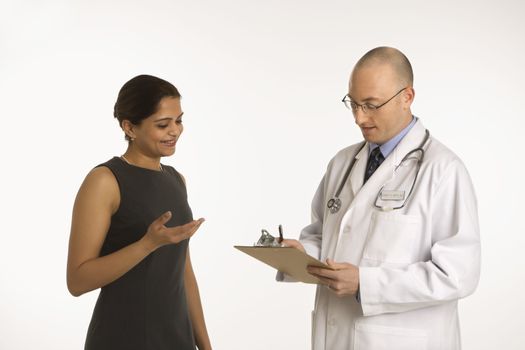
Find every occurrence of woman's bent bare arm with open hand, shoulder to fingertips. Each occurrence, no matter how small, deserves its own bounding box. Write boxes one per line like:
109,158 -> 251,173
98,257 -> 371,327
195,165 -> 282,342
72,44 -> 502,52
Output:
67,167 -> 203,296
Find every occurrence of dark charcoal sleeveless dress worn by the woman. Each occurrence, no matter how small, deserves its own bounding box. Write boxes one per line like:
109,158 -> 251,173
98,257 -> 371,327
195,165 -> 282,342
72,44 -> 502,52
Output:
85,157 -> 195,350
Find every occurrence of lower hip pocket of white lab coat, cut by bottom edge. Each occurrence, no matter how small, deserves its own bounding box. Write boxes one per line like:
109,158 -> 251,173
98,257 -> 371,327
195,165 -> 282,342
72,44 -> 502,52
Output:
354,323 -> 427,350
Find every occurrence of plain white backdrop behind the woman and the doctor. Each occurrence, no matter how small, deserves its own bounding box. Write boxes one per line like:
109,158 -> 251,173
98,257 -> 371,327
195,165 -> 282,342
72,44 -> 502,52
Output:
0,0 -> 525,349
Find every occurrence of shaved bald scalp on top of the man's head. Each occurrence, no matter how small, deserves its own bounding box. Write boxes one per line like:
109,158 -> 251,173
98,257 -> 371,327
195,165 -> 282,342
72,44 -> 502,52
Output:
354,46 -> 414,86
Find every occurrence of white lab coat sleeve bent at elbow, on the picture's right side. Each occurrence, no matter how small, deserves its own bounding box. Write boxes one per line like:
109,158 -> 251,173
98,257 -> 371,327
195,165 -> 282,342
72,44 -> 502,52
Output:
359,160 -> 481,316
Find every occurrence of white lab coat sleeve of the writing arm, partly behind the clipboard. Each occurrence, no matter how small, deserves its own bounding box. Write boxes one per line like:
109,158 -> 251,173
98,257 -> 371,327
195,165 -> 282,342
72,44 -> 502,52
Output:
276,177 -> 324,282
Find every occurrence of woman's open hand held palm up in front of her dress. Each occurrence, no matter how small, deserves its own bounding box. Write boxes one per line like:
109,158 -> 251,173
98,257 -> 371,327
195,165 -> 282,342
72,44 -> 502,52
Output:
141,211 -> 204,251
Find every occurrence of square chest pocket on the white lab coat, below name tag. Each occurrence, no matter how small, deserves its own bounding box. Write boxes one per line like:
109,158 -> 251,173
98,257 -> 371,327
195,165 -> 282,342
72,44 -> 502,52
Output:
363,211 -> 422,264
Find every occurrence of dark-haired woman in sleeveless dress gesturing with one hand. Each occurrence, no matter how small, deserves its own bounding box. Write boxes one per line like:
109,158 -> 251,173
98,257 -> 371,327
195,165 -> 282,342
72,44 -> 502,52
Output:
67,75 -> 211,350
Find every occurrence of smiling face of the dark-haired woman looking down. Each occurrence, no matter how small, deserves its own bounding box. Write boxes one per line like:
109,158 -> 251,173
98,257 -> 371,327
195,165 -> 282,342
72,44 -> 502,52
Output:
128,97 -> 184,158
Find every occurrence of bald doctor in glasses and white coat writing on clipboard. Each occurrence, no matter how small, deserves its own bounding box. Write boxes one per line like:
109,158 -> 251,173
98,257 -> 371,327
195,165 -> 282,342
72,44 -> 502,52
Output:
278,47 -> 480,350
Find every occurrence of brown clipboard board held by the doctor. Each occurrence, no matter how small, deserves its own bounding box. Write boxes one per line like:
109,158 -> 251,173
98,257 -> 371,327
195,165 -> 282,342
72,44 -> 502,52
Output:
233,245 -> 333,284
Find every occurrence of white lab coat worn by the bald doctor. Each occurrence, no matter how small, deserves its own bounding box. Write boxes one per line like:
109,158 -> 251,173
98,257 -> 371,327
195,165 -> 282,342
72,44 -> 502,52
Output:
282,120 -> 480,350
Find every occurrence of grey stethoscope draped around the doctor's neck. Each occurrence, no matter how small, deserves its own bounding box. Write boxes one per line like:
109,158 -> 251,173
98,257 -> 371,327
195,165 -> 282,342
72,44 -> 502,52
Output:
326,130 -> 430,214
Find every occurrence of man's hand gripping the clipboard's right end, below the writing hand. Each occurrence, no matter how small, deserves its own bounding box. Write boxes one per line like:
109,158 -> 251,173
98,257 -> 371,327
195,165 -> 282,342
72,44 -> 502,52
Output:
308,259 -> 359,297
